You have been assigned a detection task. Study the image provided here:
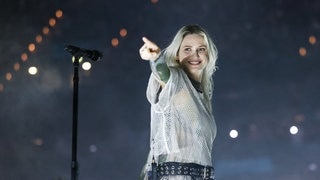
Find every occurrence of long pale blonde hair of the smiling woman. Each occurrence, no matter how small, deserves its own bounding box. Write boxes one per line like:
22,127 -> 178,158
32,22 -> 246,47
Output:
164,25 -> 218,101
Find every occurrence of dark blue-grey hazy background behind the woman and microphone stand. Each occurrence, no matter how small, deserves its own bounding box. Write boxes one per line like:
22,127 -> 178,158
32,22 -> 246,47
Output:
0,0 -> 320,180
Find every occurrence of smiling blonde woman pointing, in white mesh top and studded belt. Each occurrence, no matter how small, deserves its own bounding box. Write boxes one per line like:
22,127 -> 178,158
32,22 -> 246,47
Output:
139,25 -> 217,180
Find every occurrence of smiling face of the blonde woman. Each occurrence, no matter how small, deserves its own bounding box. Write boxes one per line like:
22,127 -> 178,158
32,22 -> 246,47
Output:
177,34 -> 208,82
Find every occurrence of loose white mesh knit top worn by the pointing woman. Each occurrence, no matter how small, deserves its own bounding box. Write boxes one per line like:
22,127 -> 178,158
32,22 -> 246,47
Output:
146,67 -> 216,179
